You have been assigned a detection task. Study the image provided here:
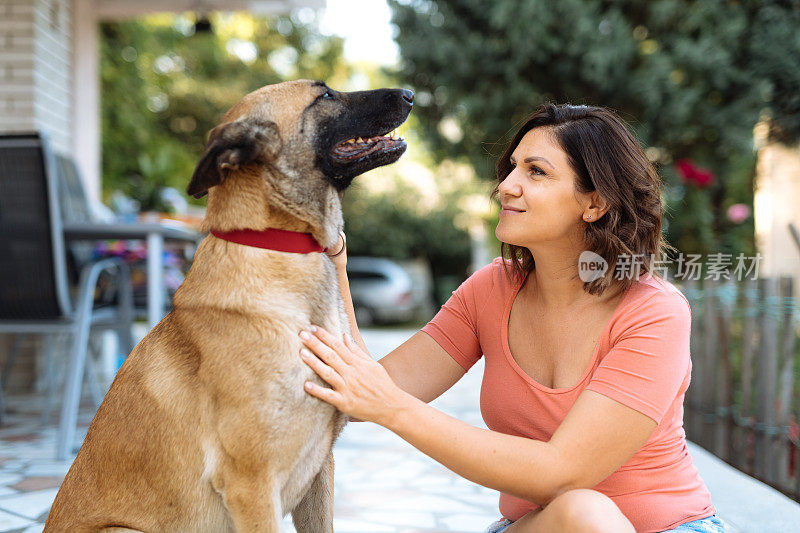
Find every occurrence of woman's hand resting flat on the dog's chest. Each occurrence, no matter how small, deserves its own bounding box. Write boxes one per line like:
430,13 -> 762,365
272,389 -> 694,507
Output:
300,326 -> 409,426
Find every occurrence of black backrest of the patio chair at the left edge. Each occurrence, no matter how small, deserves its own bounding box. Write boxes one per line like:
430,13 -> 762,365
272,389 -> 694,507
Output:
0,133 -> 72,320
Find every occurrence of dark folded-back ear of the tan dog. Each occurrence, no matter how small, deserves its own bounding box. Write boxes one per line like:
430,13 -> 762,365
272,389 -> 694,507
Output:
186,118 -> 281,198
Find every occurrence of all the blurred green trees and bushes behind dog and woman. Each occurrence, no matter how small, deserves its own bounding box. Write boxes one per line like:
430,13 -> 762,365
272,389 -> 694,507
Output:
101,0 -> 800,303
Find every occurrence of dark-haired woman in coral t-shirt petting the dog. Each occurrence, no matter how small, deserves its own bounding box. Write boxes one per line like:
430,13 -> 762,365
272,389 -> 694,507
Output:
301,104 -> 724,533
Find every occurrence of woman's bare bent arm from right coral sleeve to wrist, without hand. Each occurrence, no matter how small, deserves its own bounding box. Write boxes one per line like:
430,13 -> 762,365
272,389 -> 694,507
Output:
386,387 -> 657,506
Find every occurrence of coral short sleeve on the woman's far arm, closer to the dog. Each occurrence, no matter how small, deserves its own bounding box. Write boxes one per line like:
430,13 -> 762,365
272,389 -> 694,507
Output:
422,260 -> 498,370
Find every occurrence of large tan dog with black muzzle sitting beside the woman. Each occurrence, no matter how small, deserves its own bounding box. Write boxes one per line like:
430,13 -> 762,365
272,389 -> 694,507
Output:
45,80 -> 412,533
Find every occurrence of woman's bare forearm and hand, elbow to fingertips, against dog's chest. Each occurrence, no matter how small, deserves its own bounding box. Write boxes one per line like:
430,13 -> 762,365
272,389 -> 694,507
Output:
301,328 -> 568,505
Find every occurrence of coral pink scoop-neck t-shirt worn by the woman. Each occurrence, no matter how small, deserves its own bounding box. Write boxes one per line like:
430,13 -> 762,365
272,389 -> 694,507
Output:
422,258 -> 716,533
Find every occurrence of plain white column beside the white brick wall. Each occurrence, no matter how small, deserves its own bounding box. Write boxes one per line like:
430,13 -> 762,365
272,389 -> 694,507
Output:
72,0 -> 101,201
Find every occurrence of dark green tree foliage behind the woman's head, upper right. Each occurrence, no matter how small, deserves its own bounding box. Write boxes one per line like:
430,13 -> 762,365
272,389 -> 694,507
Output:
389,0 -> 800,253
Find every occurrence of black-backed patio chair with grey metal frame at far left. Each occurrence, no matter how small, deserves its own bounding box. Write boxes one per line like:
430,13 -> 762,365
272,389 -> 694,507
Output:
0,133 -> 134,460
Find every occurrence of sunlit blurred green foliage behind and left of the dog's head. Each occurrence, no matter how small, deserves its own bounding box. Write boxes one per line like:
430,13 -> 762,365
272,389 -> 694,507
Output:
100,13 -> 347,210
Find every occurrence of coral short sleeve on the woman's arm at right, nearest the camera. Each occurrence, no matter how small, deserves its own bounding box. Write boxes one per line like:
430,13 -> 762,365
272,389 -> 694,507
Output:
586,292 -> 691,424
